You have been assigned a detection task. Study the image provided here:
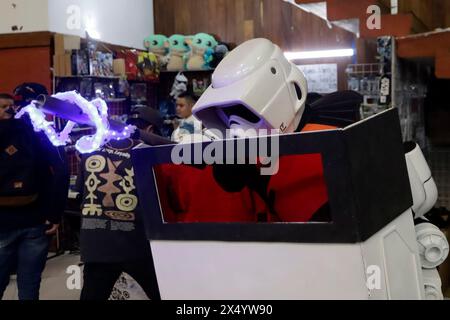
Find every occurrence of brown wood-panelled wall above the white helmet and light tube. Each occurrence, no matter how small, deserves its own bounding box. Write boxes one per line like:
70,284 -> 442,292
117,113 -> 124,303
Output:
154,0 -> 360,90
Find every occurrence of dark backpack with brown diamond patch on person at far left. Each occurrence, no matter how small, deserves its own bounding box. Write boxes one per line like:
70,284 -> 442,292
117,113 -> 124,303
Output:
0,120 -> 39,207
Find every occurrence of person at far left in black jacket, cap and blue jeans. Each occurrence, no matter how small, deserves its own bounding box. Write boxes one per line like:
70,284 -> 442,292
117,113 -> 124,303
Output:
0,84 -> 69,300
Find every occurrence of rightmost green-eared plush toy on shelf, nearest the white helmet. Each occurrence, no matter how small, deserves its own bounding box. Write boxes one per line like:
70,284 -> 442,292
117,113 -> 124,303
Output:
186,33 -> 217,70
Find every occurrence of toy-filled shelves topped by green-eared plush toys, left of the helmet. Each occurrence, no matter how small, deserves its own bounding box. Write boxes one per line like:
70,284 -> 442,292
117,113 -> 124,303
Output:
53,33 -> 230,175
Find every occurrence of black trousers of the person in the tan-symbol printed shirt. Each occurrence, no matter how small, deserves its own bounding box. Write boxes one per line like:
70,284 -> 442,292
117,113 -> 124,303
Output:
80,259 -> 161,301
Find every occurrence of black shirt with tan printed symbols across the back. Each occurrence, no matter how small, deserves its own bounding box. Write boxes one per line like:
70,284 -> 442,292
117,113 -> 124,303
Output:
77,139 -> 150,263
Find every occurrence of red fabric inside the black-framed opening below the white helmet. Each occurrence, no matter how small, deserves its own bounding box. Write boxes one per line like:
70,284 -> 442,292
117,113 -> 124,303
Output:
155,124 -> 335,223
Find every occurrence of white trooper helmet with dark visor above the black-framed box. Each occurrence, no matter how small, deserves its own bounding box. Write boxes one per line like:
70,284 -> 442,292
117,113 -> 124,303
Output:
193,39 -> 307,136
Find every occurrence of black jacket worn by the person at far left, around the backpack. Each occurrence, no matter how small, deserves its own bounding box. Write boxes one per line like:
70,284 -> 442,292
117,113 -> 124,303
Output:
0,119 -> 69,232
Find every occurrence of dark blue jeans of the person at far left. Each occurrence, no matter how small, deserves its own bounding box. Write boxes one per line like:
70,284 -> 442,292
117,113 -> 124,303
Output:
0,225 -> 49,300
